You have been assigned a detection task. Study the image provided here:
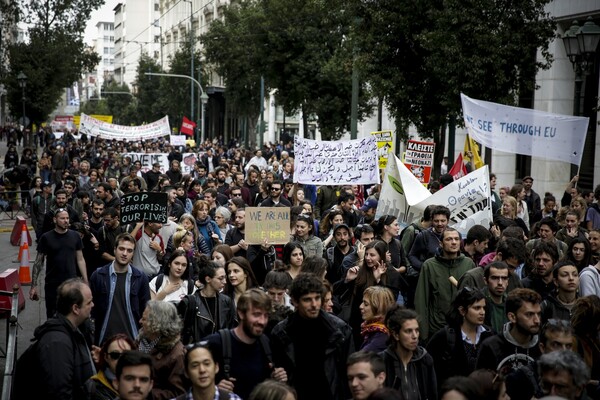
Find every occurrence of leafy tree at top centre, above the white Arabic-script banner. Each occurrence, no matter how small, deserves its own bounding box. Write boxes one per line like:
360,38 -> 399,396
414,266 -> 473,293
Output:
202,0 -> 372,139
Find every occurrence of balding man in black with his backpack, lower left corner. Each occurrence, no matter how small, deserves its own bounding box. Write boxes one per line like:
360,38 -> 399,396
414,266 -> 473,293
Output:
12,278 -> 96,400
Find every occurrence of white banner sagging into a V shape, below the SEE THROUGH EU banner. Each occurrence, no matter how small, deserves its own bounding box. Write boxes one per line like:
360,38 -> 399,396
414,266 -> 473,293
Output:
375,157 -> 493,235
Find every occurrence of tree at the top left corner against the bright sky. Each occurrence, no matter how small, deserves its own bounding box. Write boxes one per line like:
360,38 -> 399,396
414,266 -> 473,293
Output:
0,0 -> 104,122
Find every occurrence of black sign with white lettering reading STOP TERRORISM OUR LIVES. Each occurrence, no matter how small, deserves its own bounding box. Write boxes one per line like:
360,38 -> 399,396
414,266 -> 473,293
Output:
121,192 -> 167,224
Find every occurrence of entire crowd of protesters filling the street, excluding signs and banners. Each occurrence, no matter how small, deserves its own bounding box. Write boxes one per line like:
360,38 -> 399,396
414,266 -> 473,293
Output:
2,126 -> 600,400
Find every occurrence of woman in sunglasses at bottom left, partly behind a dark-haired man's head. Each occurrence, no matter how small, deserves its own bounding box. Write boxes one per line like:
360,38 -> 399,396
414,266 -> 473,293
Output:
85,333 -> 136,400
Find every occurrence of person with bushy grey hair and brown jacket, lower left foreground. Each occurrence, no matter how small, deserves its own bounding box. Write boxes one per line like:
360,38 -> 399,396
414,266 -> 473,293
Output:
136,300 -> 187,400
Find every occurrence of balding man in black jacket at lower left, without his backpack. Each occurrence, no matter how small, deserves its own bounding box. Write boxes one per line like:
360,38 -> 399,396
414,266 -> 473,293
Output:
32,278 -> 96,400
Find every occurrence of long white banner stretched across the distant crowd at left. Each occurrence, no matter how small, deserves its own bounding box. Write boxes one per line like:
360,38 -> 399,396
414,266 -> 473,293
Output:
79,114 -> 171,142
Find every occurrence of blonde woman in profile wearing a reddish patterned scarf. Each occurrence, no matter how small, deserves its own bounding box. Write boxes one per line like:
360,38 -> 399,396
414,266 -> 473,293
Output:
360,286 -> 396,353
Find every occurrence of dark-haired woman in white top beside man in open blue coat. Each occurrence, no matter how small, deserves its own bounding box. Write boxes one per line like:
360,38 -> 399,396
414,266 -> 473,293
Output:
150,248 -> 196,303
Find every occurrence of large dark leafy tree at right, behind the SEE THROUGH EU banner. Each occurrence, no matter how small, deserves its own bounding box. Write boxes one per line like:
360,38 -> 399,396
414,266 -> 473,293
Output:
354,0 -> 555,163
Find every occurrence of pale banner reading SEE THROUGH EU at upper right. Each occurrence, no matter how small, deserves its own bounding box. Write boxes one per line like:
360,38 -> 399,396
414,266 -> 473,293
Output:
460,93 -> 589,165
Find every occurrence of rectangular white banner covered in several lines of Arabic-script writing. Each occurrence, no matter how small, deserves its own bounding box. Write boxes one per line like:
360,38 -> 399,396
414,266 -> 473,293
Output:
294,136 -> 379,185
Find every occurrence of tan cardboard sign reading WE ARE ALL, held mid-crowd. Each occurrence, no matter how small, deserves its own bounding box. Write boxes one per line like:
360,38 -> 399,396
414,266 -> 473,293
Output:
244,207 -> 290,244
